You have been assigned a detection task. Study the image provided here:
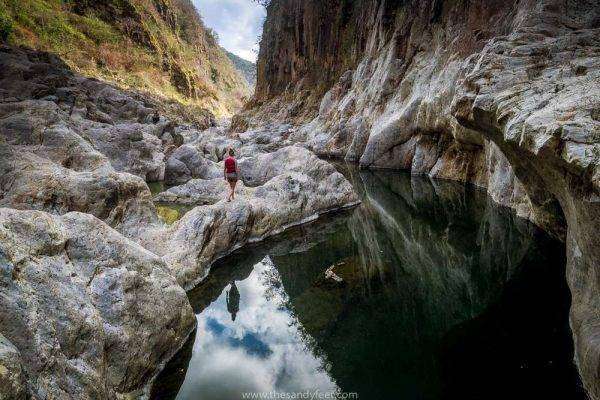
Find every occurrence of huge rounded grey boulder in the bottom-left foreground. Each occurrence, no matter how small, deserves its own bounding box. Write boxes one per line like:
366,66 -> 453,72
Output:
0,209 -> 195,399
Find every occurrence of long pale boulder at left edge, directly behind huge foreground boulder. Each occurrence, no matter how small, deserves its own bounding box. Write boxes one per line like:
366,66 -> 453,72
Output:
0,144 -> 157,236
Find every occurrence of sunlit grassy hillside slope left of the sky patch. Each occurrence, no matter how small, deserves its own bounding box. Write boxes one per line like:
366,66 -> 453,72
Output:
0,0 -> 249,115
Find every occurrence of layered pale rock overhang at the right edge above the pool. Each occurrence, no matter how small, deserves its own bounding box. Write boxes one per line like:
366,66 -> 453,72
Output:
453,23 -> 600,399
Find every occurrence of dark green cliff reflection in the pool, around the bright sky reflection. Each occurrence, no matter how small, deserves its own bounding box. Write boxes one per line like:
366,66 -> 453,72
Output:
150,171 -> 583,399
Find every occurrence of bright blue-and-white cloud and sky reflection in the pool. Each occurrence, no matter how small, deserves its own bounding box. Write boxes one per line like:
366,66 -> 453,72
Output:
177,257 -> 337,400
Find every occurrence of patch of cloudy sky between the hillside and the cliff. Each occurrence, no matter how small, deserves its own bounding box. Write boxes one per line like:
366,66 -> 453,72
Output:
193,0 -> 266,62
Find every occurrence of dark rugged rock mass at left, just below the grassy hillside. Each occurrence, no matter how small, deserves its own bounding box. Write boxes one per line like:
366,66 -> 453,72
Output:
0,47 -> 165,181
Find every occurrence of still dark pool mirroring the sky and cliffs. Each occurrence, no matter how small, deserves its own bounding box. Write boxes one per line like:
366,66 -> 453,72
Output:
152,171 -> 584,400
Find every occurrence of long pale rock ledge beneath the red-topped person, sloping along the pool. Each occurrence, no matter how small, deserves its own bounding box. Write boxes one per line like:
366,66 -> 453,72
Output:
157,166 -> 358,288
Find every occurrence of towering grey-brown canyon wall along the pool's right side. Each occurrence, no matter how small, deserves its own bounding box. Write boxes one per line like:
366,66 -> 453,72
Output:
243,0 -> 600,399
